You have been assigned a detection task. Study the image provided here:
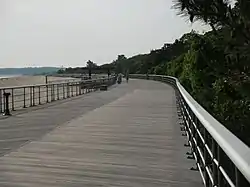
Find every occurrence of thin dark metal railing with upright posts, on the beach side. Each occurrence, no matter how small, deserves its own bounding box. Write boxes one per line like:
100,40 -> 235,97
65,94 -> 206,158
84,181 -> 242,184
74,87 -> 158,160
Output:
0,76 -> 116,113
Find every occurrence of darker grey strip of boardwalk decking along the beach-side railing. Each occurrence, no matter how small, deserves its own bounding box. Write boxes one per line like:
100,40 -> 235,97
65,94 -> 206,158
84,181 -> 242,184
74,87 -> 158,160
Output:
0,82 -> 134,156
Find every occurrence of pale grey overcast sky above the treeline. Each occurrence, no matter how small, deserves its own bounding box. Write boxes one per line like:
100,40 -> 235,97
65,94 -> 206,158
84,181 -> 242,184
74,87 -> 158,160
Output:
0,0 -> 209,67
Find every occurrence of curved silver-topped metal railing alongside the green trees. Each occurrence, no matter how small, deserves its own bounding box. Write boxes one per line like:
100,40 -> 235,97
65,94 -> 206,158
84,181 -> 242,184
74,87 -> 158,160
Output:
130,74 -> 250,187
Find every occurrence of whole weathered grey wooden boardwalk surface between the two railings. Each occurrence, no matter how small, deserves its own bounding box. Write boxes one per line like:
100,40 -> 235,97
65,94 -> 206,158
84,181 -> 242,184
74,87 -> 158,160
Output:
0,80 -> 202,187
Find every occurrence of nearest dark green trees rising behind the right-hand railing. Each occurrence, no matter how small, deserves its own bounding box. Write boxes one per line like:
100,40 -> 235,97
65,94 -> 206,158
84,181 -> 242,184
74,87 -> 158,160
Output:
172,0 -> 250,145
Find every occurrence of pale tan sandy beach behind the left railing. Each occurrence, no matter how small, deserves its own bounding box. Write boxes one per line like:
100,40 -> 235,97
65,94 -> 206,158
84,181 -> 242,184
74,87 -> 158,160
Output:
0,76 -> 80,112
